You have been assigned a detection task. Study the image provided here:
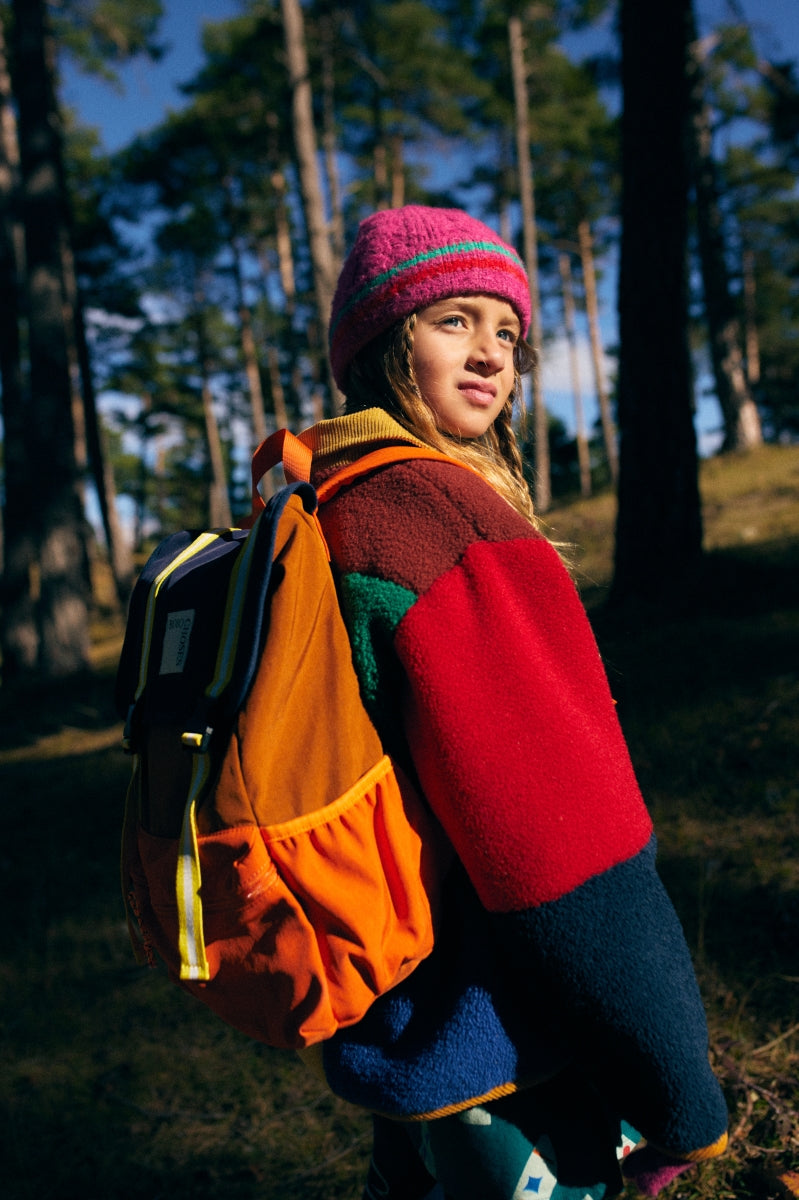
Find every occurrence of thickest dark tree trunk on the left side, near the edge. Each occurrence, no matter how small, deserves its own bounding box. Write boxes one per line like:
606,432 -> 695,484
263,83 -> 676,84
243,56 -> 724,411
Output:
10,0 -> 89,678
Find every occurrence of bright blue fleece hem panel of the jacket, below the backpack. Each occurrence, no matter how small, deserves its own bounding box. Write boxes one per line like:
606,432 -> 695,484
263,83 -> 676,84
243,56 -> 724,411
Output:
323,866 -> 570,1117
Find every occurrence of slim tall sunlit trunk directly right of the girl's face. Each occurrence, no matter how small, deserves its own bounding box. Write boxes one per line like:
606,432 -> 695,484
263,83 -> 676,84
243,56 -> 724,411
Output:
507,17 -> 552,512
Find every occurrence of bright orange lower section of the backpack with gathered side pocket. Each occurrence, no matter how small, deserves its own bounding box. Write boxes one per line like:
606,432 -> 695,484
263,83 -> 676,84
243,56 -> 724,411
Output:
127,757 -> 437,1049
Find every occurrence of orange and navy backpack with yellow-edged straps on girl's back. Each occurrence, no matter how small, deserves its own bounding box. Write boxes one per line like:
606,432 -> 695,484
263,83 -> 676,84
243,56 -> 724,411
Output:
116,430 -> 451,1049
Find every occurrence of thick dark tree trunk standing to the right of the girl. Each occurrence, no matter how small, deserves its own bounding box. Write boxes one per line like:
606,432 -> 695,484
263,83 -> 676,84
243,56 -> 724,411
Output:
612,0 -> 702,602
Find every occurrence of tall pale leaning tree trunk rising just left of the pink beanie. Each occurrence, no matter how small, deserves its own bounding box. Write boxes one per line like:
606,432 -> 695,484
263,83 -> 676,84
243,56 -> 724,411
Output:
281,0 -> 342,412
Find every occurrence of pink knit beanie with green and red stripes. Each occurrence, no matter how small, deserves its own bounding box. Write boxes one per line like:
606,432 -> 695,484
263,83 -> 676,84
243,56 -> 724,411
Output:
330,204 -> 530,391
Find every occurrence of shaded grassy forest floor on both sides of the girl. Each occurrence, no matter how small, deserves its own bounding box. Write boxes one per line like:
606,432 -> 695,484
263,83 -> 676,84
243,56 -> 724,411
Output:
0,448 -> 799,1200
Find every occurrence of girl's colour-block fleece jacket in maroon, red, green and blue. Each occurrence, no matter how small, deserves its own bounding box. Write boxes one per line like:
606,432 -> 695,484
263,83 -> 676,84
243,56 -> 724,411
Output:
295,409 -> 727,1159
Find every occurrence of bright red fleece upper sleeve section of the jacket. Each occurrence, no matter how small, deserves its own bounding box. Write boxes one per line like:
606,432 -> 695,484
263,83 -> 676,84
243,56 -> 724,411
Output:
395,538 -> 651,912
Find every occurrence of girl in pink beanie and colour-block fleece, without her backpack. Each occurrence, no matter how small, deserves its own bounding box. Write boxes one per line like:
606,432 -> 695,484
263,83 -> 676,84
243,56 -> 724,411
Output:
291,206 -> 727,1200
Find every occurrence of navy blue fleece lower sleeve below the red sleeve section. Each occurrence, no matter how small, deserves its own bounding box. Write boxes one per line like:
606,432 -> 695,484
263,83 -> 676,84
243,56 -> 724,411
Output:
497,838 -> 727,1154
